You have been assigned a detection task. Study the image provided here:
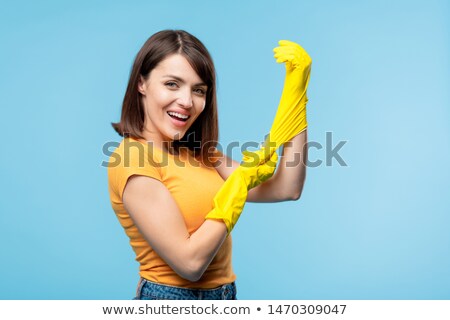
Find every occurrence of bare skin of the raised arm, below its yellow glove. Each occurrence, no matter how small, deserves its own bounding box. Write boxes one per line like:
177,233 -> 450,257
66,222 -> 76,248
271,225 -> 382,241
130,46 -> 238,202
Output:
216,130 -> 307,202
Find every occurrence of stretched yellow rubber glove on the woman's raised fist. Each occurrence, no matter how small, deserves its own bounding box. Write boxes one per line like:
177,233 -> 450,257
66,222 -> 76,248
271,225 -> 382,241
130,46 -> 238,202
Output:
265,40 -> 312,149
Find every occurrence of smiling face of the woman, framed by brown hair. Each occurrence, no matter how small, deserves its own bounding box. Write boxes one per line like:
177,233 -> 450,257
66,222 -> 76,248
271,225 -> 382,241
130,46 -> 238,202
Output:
139,54 -> 207,143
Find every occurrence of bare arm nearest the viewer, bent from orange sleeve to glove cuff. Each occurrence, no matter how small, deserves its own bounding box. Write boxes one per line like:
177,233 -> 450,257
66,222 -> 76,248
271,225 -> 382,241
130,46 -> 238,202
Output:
123,175 -> 227,281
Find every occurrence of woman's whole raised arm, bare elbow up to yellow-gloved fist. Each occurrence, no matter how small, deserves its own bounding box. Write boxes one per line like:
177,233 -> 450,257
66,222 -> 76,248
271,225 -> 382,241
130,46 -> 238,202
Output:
216,40 -> 312,202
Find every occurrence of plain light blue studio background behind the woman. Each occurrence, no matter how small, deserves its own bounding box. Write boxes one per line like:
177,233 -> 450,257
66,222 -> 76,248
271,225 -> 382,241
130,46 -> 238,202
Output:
0,0 -> 450,299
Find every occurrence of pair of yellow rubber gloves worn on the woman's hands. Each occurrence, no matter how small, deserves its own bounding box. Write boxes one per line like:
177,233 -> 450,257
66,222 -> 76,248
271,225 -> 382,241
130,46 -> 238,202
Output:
206,40 -> 311,234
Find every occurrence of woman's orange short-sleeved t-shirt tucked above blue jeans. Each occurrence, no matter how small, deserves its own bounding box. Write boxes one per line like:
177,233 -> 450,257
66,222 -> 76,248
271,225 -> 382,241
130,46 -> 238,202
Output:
108,138 -> 236,289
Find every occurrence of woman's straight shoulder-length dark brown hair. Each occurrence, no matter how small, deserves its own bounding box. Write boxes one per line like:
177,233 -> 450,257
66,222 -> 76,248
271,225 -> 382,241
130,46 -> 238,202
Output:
112,30 -> 219,162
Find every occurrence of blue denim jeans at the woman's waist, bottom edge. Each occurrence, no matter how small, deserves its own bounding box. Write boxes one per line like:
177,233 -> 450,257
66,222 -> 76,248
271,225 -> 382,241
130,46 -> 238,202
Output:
133,278 -> 236,300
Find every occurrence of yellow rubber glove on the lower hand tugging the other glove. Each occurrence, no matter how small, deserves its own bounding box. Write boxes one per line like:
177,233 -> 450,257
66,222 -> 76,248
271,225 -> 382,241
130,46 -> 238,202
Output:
205,150 -> 278,234
